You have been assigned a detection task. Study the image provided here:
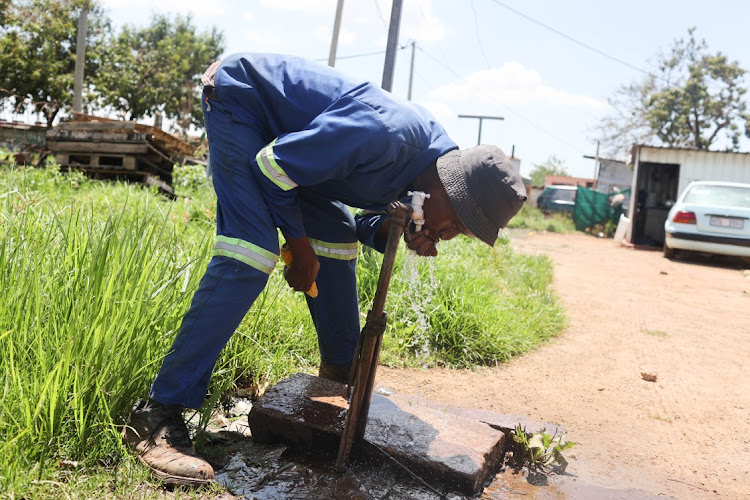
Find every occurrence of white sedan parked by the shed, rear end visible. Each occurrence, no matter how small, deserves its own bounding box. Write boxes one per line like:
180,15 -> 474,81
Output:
664,181 -> 750,258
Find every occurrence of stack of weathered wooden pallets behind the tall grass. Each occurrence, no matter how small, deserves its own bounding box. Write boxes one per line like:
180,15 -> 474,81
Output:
47,114 -> 195,197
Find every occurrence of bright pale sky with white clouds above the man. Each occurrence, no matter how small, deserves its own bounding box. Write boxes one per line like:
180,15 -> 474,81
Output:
100,0 -> 750,177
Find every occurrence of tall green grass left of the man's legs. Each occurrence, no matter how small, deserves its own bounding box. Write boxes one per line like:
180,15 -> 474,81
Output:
0,167 -> 210,492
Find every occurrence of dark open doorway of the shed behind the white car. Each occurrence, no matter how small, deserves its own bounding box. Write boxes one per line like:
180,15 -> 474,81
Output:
632,162 -> 680,246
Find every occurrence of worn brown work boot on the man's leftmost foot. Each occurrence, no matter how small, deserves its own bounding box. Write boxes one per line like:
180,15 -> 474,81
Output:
122,399 -> 214,485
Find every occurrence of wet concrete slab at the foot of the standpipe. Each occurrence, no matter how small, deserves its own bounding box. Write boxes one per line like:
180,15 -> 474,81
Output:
248,373 -> 505,495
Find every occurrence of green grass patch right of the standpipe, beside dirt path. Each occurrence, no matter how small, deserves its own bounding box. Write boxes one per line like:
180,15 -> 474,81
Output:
378,237 -> 565,368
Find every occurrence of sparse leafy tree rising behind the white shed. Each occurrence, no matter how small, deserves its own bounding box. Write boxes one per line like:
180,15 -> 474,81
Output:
598,28 -> 750,156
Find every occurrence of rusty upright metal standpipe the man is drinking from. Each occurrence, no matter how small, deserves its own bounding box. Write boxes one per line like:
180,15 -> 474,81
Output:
336,201 -> 412,470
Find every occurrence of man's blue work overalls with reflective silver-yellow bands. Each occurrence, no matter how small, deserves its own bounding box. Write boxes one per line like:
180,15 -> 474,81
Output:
150,53 -> 457,408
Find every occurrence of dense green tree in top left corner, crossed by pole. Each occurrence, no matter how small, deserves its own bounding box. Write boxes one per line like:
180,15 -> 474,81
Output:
0,0 -> 109,127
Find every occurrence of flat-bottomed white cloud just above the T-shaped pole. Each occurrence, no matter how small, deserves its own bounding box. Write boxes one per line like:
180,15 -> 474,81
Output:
428,61 -> 607,111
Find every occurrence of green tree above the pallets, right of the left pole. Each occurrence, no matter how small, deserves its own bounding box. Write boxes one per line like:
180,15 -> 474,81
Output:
96,15 -> 224,134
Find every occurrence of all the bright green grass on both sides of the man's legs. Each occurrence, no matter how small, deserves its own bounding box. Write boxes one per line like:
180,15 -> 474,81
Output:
0,159 -> 564,498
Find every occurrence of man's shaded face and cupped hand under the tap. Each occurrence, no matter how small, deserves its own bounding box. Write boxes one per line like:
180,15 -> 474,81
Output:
405,182 -> 474,257
